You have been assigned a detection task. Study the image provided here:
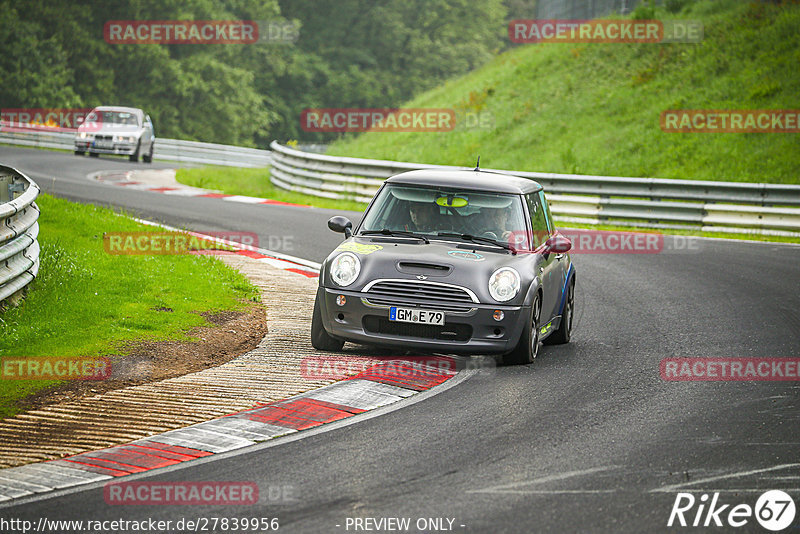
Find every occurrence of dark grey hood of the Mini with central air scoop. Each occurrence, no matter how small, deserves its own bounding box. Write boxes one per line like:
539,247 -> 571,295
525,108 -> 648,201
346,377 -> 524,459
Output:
320,237 -> 533,304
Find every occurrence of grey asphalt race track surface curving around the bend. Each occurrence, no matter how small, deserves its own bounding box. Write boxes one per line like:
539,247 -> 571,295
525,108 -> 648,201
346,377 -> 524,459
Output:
0,147 -> 800,532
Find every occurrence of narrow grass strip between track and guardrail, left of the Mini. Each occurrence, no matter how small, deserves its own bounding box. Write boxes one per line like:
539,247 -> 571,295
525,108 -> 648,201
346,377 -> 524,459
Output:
175,166 -> 366,211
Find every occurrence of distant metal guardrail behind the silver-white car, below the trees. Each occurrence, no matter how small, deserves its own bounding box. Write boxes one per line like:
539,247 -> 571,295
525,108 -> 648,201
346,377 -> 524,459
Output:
0,123 -> 271,167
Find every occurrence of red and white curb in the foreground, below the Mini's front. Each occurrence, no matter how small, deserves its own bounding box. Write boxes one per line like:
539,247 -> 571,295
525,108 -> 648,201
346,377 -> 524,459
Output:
0,357 -> 458,504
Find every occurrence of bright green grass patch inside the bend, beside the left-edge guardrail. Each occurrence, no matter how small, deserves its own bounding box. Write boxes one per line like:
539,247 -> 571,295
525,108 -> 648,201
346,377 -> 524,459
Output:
0,195 -> 258,417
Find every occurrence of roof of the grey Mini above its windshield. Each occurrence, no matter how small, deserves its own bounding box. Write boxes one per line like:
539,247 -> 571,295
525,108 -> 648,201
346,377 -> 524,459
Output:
386,169 -> 542,195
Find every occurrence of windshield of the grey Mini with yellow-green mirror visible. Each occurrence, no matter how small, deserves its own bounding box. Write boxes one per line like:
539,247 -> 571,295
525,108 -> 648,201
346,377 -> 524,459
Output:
359,184 -> 525,247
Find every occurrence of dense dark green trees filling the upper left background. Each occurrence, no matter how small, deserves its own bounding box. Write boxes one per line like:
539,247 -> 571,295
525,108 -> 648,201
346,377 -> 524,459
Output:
0,0 -> 508,146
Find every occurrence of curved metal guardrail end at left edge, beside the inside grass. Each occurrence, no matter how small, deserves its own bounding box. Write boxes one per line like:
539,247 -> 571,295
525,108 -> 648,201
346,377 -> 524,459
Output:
0,165 -> 39,310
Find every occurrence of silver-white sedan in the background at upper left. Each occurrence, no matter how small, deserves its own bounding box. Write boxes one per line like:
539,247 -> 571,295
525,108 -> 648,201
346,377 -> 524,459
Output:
75,106 -> 156,163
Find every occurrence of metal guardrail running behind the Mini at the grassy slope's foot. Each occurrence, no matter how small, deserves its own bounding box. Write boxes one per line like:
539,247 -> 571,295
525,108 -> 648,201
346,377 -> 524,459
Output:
270,141 -> 800,236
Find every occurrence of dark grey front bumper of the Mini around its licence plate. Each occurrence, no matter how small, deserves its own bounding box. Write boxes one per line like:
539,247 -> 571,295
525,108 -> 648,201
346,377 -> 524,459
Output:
317,287 -> 530,354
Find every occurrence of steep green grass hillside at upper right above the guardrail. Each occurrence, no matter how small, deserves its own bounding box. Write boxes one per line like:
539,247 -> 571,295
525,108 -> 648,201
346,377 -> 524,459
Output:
328,0 -> 800,184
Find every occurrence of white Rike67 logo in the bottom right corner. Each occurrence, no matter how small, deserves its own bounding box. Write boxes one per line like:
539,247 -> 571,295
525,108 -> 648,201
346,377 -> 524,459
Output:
667,490 -> 796,532
